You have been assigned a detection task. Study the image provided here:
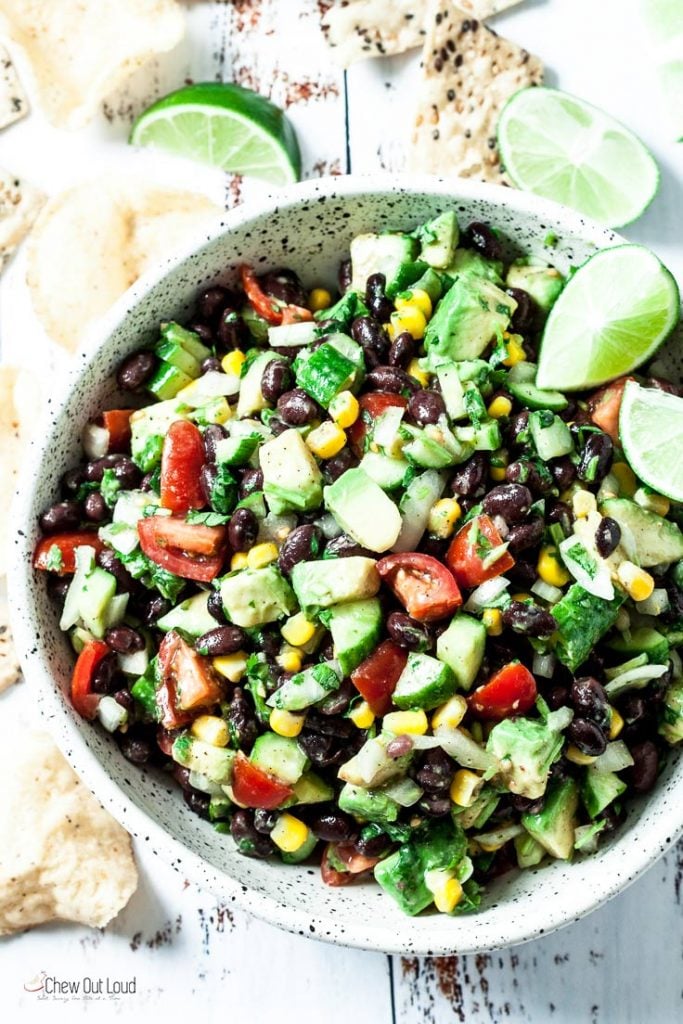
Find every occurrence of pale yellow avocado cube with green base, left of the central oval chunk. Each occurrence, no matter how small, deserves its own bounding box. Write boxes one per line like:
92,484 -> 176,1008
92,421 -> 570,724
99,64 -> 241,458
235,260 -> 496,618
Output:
259,430 -> 323,515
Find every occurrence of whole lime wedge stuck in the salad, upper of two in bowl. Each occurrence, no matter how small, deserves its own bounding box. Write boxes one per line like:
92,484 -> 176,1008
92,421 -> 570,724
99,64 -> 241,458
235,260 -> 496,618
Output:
537,245 -> 680,391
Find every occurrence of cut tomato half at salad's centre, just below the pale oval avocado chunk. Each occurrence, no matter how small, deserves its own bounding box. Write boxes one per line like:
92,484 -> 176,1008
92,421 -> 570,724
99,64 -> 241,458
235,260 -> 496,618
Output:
377,551 -> 463,623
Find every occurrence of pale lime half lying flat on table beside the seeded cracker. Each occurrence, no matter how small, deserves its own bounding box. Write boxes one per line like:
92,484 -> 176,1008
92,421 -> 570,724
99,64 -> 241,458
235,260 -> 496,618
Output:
498,86 -> 659,227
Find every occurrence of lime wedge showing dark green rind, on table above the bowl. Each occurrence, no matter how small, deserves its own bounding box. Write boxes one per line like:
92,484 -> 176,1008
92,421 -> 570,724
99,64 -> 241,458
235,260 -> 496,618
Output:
130,82 -> 301,185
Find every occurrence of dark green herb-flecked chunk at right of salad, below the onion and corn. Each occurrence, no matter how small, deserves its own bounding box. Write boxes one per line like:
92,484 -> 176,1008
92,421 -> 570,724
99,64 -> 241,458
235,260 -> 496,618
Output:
551,583 -> 626,672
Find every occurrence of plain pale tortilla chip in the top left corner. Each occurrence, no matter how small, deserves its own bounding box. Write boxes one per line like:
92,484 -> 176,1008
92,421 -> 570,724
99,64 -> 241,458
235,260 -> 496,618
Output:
0,0 -> 184,128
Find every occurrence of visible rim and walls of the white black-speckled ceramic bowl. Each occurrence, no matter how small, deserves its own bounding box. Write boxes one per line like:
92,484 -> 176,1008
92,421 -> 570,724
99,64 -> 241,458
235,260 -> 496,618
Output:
11,177 -> 683,954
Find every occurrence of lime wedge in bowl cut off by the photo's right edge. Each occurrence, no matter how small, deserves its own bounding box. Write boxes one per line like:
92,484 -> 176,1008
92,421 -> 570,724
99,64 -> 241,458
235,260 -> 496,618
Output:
618,381 -> 683,502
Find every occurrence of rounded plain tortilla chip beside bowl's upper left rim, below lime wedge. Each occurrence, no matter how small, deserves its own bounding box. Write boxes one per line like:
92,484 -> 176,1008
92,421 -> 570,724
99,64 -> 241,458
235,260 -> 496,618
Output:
27,178 -> 222,351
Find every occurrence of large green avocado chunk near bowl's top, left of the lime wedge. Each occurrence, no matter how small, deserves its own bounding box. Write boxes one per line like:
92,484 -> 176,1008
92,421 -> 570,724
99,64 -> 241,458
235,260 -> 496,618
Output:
425,276 -> 517,359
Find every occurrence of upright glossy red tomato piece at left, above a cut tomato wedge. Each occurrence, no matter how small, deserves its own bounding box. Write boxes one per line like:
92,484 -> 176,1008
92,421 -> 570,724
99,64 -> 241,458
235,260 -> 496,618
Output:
161,420 -> 206,515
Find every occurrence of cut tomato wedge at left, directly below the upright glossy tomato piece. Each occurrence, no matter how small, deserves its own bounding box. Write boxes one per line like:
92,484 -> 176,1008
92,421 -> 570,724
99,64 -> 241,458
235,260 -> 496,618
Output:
137,515 -> 226,583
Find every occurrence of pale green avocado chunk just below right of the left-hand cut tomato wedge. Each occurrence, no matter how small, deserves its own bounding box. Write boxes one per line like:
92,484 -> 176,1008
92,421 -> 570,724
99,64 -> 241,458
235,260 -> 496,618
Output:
220,565 -> 296,629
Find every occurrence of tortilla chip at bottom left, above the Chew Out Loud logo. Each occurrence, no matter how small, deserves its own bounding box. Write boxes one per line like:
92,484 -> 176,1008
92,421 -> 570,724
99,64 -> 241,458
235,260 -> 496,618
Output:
0,729 -> 137,935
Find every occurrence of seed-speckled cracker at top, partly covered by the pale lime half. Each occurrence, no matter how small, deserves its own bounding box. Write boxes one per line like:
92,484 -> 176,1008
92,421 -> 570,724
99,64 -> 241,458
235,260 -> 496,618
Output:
408,0 -> 543,184
